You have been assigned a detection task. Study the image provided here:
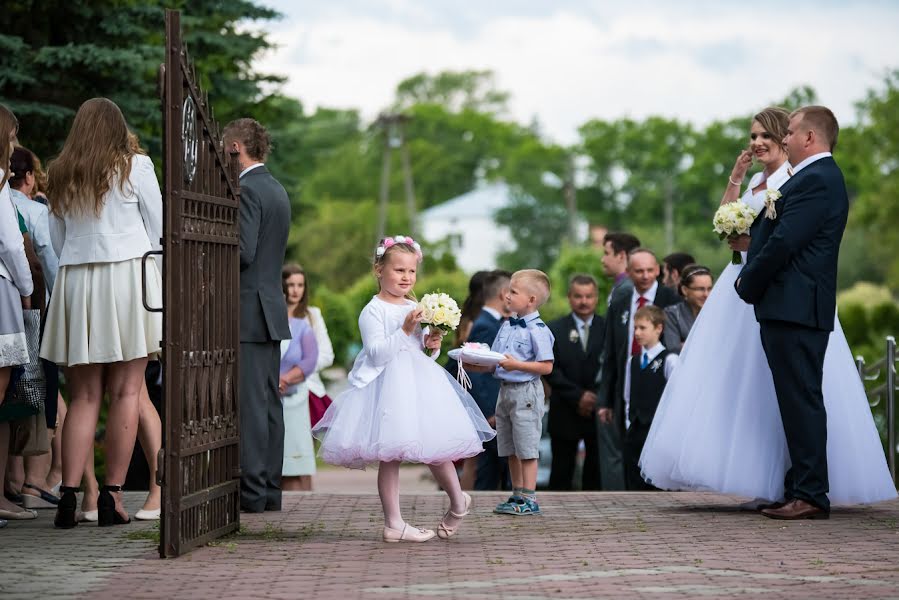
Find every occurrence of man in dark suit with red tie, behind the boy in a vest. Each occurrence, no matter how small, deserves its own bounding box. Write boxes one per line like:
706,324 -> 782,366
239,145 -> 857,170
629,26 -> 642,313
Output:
596,248 -> 682,490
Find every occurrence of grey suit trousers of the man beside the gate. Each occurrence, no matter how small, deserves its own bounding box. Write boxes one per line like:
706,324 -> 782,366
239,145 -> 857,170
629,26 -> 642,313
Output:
240,341 -> 284,512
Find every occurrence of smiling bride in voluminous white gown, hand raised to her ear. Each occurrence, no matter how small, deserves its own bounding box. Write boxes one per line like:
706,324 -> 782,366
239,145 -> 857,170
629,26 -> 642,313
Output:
640,108 -> 896,505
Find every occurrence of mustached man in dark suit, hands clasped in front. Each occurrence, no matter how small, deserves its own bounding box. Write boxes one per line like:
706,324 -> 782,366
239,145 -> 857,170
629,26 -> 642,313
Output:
546,274 -> 604,491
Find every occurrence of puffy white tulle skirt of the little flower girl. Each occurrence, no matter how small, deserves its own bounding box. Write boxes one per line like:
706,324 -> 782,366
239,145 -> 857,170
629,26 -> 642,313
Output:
312,349 -> 496,469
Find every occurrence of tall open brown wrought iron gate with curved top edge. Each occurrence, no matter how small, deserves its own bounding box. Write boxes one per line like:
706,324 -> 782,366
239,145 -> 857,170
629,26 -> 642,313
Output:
159,10 -> 240,557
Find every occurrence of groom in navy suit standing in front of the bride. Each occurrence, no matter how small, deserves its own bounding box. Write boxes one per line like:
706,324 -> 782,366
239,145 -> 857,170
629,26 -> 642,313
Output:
735,106 -> 849,519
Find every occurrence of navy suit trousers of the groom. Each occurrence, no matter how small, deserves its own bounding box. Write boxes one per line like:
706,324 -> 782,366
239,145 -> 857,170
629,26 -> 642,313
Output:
759,320 -> 830,510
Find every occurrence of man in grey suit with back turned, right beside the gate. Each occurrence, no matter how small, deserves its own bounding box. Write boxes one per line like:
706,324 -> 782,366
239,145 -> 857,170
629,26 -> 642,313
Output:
223,119 -> 290,512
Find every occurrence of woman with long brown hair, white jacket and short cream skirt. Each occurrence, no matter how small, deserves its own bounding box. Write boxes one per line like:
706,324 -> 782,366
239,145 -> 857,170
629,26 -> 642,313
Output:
41,98 -> 162,529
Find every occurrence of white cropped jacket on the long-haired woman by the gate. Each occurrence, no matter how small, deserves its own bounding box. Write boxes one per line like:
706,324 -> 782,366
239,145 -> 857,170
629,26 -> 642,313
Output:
50,154 -> 162,267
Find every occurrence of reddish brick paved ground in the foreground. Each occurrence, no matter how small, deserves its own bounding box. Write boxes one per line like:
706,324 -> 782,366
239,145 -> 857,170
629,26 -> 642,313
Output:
0,493 -> 899,600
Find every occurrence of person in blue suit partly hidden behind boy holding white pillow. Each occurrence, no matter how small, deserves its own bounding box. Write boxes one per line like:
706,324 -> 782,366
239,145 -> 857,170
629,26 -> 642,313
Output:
468,270 -> 512,491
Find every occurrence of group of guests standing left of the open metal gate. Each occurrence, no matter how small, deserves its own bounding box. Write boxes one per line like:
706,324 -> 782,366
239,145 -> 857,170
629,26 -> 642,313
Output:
0,98 -> 162,528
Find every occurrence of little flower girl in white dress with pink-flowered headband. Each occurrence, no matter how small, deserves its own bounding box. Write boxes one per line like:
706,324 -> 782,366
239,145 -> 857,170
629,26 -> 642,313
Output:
312,236 -> 495,542
